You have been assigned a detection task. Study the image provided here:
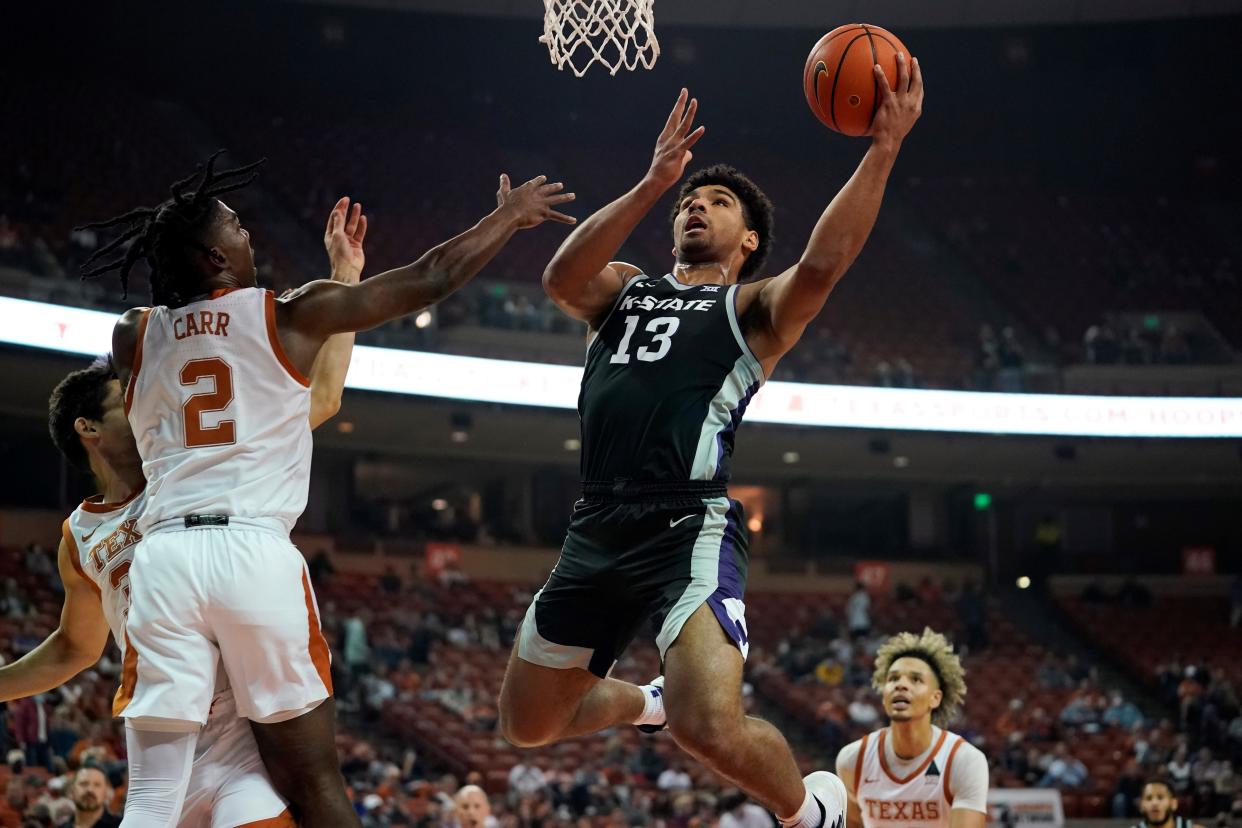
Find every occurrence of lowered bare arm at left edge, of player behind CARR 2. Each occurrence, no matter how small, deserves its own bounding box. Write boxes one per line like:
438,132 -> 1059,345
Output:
0,539 -> 108,701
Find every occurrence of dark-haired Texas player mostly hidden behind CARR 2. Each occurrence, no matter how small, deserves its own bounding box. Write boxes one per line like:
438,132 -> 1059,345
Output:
0,200 -> 366,828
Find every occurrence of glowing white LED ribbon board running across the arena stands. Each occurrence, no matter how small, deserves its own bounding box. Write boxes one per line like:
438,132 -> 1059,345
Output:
7,297 -> 1242,437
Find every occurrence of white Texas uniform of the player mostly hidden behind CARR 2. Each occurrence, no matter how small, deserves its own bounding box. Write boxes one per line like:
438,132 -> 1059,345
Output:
61,489 -> 294,828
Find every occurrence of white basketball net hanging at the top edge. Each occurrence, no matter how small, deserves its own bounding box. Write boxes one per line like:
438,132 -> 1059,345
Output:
539,0 -> 660,77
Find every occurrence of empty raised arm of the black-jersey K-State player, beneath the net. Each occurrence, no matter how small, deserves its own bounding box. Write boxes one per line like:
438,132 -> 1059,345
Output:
544,89 -> 705,323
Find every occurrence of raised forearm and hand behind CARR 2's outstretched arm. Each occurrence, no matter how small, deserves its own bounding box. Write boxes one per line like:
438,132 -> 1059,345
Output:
309,196 -> 366,431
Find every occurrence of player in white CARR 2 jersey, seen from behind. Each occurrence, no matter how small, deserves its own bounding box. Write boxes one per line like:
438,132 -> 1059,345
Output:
76,150 -> 574,828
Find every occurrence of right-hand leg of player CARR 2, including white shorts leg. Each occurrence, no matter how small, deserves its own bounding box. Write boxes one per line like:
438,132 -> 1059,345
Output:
211,528 -> 359,828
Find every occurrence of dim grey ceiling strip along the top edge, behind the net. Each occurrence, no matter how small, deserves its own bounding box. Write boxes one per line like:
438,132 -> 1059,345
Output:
291,0 -> 1242,28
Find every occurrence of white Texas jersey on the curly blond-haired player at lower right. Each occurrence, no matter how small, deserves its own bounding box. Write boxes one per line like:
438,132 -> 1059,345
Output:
837,726 -> 987,828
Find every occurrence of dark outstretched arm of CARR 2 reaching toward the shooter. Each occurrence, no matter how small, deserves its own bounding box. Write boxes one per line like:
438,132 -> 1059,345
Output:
277,175 -> 575,357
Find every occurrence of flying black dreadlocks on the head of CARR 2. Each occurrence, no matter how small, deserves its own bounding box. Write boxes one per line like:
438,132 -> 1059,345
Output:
75,149 -> 267,308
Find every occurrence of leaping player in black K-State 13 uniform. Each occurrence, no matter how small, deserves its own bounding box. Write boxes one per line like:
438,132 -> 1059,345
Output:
499,56 -> 923,828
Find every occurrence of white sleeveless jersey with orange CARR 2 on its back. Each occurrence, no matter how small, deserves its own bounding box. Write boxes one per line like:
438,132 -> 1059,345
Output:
125,288 -> 311,531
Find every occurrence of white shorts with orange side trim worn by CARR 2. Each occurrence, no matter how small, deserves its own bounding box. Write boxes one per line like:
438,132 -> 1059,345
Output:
120,518 -> 332,730
